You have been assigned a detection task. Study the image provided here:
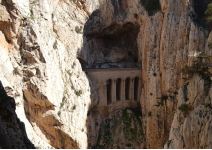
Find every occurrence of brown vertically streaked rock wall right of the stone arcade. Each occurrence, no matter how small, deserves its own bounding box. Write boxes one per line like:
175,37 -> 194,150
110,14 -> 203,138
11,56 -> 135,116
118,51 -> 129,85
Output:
140,1 -> 211,148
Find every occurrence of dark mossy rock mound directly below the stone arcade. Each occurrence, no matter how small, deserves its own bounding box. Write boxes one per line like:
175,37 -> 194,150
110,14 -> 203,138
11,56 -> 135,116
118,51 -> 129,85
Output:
94,109 -> 145,148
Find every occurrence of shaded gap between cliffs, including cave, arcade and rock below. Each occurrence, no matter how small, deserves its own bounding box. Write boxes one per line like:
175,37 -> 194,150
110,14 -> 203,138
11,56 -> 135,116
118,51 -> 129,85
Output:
79,4 -> 144,148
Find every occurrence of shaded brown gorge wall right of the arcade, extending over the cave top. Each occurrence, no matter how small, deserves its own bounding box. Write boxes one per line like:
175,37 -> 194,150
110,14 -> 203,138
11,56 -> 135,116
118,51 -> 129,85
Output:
85,0 -> 211,148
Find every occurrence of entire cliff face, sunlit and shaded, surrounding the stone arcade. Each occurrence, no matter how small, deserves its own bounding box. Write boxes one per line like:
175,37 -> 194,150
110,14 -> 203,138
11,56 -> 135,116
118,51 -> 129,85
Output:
0,0 -> 212,148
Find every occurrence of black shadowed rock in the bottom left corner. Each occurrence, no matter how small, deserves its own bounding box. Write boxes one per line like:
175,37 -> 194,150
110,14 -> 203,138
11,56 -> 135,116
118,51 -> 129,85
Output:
0,81 -> 35,149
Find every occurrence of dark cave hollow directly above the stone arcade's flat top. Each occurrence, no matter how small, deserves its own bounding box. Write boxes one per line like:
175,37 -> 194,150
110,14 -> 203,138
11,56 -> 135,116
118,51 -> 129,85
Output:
81,22 -> 139,68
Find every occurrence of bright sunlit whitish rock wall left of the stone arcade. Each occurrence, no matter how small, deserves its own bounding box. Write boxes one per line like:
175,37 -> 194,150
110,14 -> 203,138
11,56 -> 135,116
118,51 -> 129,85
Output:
0,0 -> 97,148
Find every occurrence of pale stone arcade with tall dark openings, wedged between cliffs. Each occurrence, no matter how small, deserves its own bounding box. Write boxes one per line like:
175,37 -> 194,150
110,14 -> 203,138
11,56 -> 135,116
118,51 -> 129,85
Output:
86,68 -> 141,113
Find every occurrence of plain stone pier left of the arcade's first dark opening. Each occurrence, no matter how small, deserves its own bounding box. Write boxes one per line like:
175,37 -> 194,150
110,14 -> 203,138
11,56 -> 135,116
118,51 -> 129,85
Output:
99,81 -> 107,106
